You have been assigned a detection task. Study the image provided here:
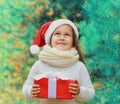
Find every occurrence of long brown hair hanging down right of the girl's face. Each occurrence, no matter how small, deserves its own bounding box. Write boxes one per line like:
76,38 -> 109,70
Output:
73,31 -> 85,64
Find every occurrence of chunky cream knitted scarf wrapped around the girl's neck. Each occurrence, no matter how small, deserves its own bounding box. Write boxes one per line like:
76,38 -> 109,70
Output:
39,45 -> 79,67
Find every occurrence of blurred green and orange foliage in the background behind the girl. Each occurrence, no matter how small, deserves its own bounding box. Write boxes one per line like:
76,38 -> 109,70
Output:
0,0 -> 120,104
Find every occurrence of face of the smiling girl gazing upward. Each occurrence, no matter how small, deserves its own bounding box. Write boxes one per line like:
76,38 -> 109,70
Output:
51,25 -> 73,50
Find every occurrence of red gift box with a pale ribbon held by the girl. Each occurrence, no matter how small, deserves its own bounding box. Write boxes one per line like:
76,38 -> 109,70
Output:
34,76 -> 75,99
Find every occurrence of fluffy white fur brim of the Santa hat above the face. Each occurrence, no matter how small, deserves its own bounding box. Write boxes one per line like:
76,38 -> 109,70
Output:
45,19 -> 78,44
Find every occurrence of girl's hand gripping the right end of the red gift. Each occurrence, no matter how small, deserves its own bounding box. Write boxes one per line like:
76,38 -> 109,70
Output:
69,80 -> 80,98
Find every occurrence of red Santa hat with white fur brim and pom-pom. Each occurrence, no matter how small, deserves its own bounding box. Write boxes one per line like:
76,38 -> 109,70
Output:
30,19 -> 79,54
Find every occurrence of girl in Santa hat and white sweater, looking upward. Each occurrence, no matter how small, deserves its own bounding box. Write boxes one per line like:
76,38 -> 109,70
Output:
22,19 -> 95,104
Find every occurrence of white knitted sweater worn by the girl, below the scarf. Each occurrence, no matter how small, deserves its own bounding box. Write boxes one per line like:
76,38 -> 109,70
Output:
22,60 -> 95,104
